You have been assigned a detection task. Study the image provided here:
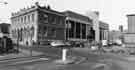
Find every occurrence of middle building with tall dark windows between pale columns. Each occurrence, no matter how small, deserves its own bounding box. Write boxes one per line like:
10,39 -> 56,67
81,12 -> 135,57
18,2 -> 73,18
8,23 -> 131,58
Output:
63,11 -> 94,41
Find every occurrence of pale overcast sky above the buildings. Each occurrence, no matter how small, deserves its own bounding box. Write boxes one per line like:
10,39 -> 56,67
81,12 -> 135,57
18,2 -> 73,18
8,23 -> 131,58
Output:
0,0 -> 135,30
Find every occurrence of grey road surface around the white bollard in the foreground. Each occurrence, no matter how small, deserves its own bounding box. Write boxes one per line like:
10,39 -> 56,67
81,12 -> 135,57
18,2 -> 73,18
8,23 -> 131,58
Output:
0,47 -> 135,70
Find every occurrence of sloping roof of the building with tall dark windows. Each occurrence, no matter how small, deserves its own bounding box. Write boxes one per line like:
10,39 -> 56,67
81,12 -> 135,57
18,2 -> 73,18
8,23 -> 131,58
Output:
63,11 -> 92,22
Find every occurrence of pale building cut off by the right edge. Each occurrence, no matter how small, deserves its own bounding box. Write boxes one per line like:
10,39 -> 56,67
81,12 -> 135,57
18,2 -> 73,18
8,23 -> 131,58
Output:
124,14 -> 135,47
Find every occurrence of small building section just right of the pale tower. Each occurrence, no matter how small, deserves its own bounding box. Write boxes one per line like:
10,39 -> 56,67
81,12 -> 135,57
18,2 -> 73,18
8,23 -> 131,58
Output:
99,21 -> 109,40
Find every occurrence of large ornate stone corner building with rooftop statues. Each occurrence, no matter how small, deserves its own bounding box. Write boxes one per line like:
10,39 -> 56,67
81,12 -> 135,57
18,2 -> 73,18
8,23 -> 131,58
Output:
11,3 -> 65,45
